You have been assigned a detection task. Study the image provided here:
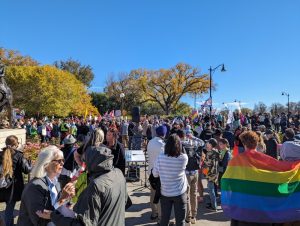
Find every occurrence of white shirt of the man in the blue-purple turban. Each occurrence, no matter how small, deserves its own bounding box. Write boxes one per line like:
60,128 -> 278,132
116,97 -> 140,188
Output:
147,137 -> 165,175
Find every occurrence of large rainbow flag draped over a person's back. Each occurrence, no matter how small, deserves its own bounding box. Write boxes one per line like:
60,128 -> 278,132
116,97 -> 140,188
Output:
221,150 -> 300,223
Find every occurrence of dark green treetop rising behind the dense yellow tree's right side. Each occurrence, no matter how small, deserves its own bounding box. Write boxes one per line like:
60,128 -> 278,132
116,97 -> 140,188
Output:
54,58 -> 95,87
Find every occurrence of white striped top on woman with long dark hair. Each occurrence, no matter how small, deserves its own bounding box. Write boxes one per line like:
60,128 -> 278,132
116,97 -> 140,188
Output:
152,153 -> 188,197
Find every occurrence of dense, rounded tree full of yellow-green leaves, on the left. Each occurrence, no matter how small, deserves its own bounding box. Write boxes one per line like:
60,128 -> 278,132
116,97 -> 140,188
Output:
6,66 -> 98,116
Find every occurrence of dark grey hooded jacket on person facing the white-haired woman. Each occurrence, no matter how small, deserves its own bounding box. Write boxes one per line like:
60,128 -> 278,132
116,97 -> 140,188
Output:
51,146 -> 127,226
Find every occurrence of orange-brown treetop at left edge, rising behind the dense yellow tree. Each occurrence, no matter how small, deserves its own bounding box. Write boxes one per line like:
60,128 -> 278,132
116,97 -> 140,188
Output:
0,47 -> 39,66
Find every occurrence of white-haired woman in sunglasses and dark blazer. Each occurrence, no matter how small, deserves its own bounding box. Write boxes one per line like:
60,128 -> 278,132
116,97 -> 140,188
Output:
17,146 -> 75,226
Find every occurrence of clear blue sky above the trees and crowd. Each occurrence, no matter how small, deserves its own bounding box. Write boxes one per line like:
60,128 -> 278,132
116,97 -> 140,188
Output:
0,0 -> 300,110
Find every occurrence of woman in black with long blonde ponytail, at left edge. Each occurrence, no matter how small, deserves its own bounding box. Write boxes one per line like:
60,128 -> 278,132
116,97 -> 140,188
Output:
0,135 -> 31,226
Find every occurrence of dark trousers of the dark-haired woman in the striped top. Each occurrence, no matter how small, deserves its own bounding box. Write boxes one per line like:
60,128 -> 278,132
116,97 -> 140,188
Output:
160,192 -> 187,226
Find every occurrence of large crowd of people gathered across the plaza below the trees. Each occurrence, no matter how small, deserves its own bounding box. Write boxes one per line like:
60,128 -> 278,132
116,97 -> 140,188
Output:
0,110 -> 300,226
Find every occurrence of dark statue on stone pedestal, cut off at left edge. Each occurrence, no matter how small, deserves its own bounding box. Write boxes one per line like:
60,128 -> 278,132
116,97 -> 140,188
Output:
0,58 -> 13,127
